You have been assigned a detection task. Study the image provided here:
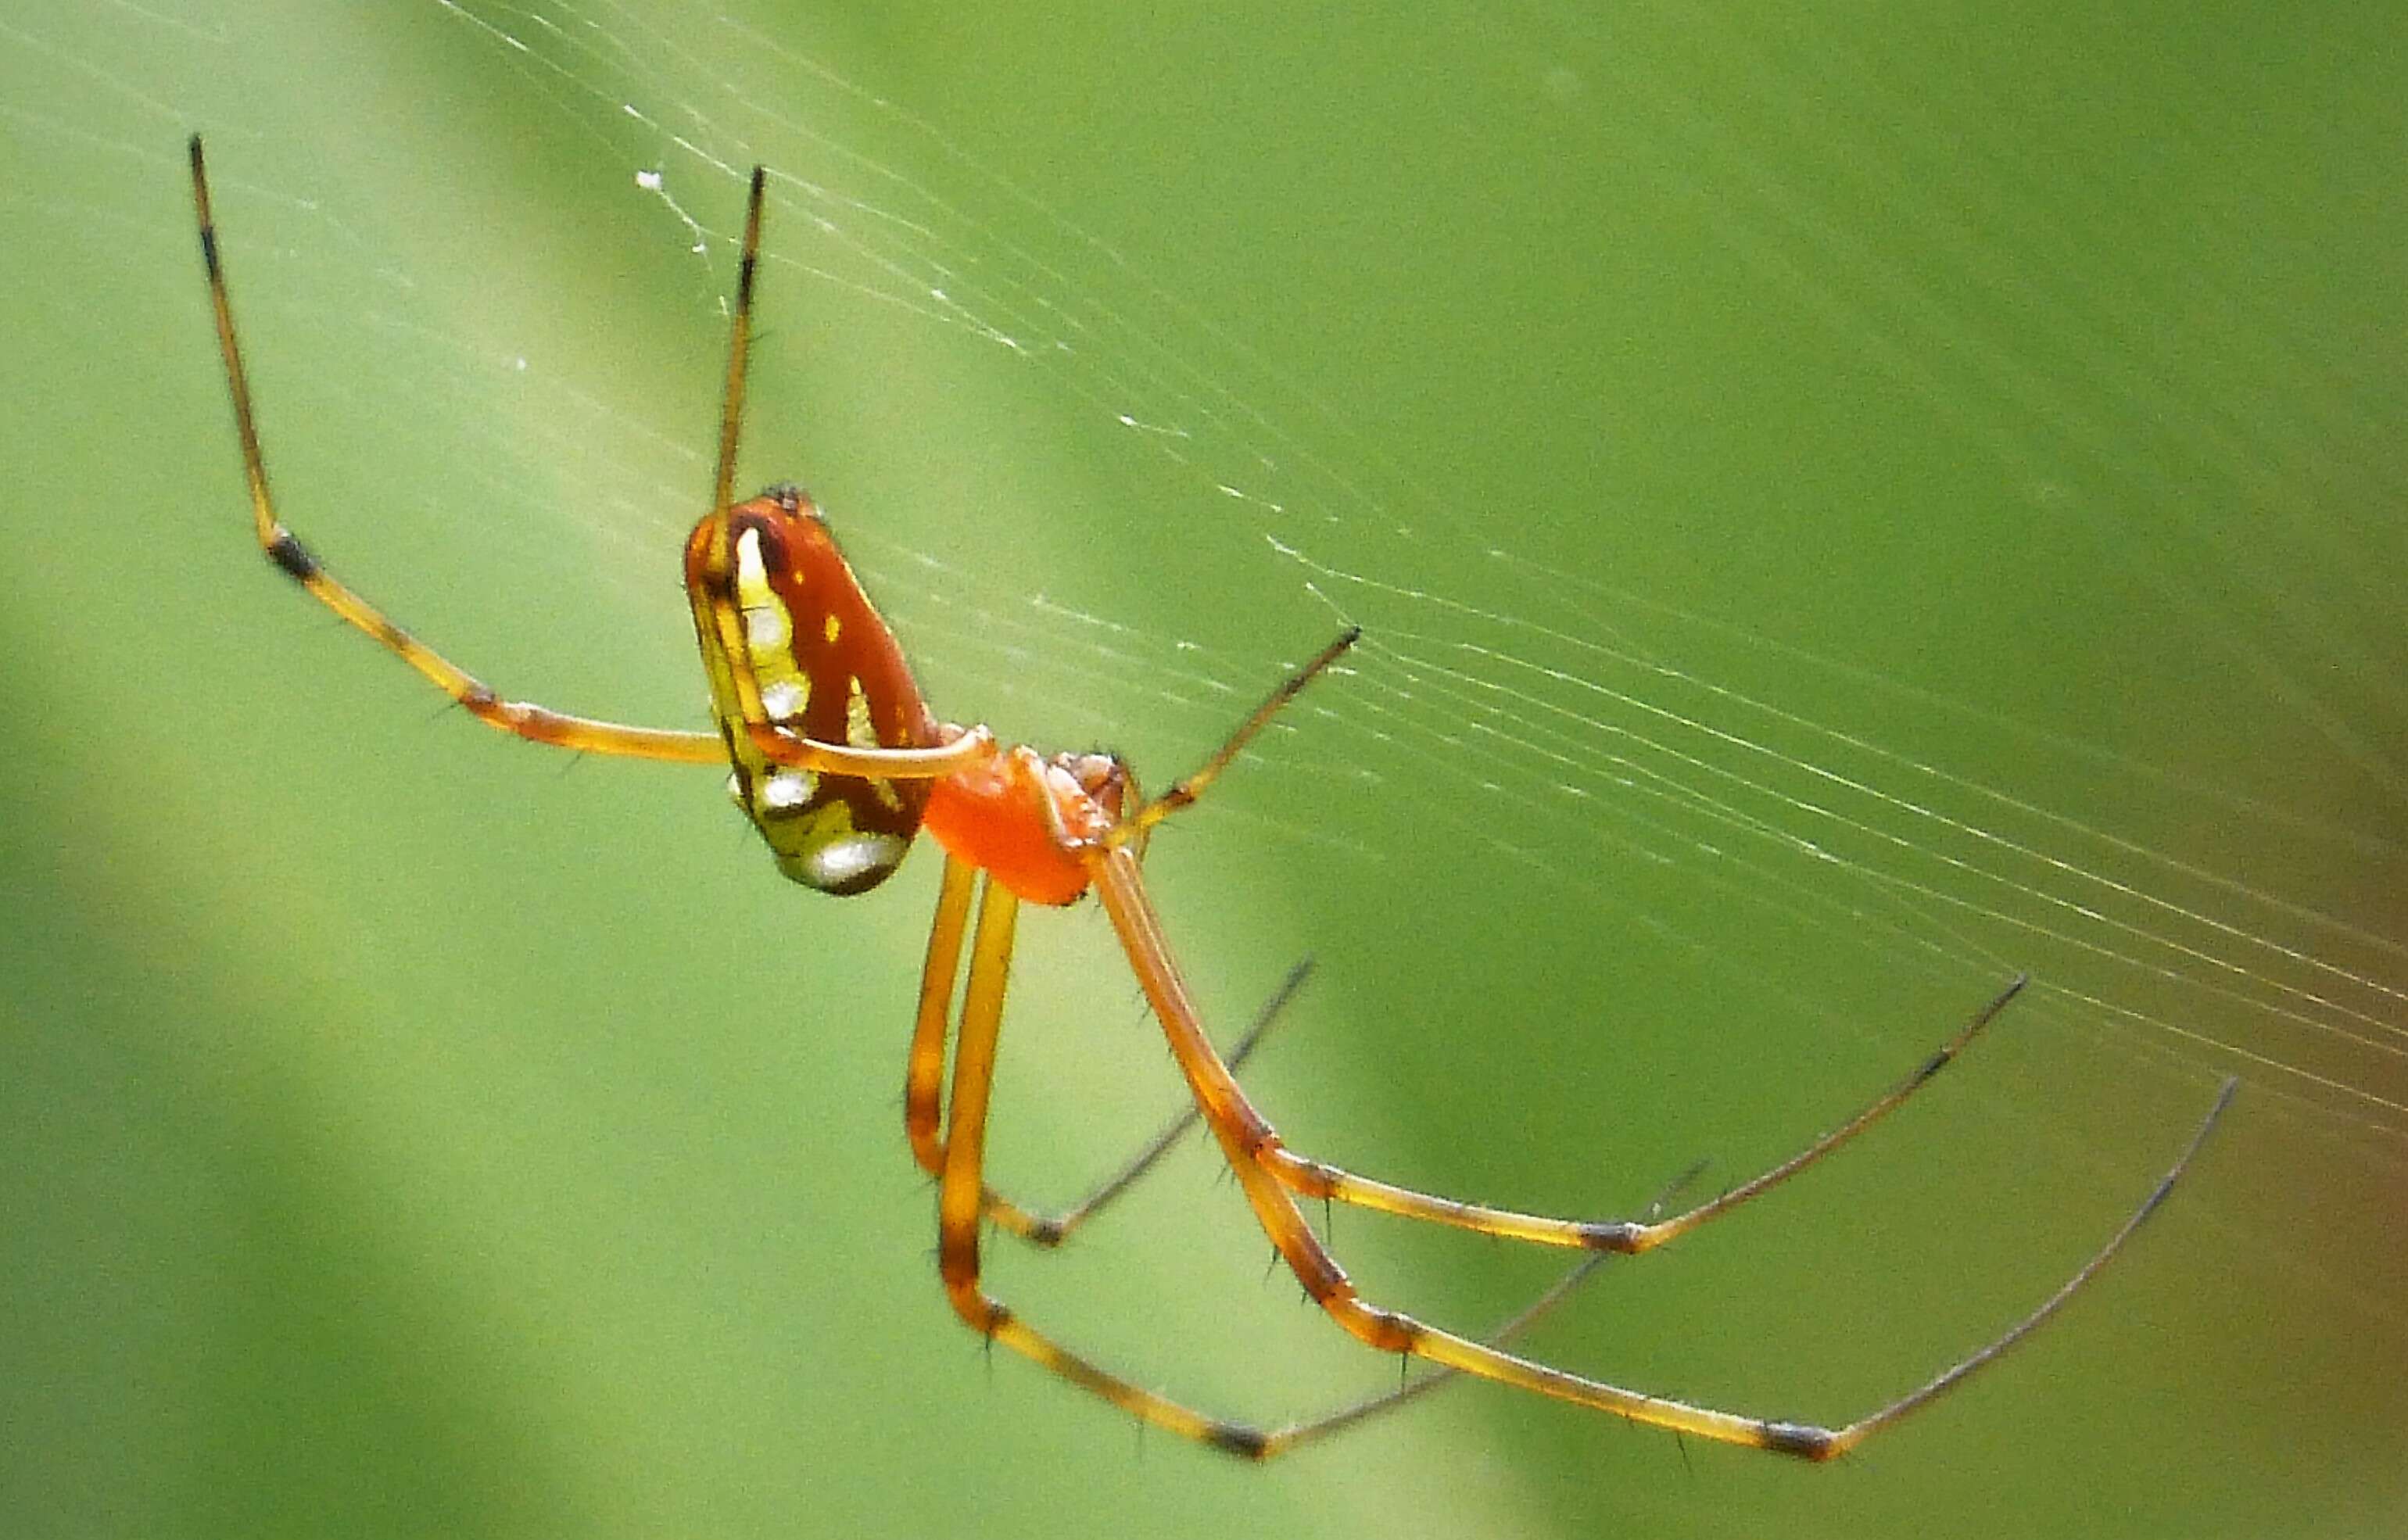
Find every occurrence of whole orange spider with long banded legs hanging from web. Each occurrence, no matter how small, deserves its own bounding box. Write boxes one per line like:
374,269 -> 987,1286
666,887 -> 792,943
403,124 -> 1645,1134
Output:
190,134 -> 2234,1460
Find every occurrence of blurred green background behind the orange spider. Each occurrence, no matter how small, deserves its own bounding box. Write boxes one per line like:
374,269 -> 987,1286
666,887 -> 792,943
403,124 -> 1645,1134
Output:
0,0 -> 2408,1535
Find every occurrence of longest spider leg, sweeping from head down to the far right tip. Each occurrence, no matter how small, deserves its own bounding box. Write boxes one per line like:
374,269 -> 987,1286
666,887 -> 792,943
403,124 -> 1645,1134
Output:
1093,850 -> 2232,1460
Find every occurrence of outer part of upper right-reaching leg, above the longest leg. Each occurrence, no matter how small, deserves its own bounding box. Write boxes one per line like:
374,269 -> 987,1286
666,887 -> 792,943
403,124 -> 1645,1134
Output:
1255,977 -> 2025,1254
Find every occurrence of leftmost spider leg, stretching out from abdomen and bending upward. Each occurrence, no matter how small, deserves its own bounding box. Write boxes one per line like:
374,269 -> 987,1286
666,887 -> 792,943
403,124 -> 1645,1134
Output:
188,134 -> 727,765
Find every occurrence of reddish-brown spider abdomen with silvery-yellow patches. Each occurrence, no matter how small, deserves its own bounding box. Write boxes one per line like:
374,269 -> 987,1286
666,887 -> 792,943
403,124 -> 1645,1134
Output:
686,486 -> 939,893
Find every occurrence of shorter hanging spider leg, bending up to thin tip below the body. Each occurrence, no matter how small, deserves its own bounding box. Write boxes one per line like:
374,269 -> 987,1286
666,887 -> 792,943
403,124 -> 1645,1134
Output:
903,857 -> 1313,1246
